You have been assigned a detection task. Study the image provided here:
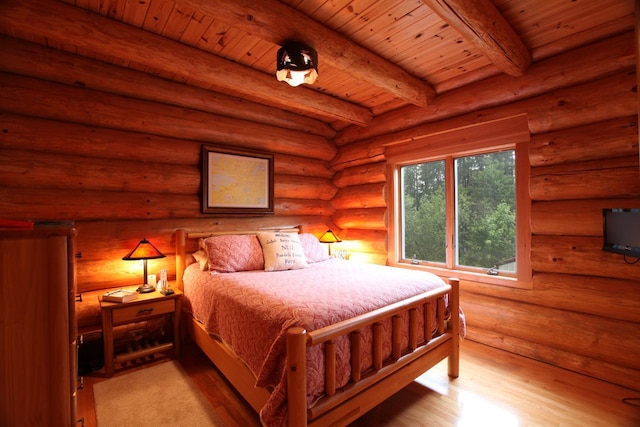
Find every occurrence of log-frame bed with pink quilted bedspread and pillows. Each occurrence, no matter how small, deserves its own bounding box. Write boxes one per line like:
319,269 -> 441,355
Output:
176,229 -> 464,426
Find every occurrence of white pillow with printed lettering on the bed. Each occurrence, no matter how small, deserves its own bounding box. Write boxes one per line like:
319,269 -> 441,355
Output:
258,232 -> 308,271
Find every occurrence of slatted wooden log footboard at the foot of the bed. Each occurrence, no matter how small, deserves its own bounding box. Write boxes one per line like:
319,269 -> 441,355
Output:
287,279 -> 460,426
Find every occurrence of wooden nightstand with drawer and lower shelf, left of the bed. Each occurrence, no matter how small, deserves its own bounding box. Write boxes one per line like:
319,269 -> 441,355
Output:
100,287 -> 182,377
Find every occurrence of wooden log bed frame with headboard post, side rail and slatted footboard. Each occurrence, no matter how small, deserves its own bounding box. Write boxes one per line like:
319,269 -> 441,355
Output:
176,230 -> 460,427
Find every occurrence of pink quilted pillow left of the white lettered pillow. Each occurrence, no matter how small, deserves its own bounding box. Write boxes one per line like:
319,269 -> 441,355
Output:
204,234 -> 264,273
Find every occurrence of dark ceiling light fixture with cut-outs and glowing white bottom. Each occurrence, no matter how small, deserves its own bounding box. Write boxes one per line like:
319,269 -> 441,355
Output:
276,42 -> 318,86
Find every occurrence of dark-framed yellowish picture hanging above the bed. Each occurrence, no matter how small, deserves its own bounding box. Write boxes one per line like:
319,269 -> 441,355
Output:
202,145 -> 273,215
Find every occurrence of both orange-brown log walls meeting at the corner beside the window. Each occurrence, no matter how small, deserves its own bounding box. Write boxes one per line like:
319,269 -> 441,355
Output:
0,15 -> 640,390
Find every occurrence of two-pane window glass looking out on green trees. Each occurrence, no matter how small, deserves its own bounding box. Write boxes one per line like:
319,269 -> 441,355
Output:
400,150 -> 517,274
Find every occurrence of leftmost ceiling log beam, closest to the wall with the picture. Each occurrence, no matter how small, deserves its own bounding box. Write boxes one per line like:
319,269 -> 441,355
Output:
0,0 -> 373,126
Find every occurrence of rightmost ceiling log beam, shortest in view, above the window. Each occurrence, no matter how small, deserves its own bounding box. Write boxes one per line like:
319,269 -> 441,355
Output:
423,0 -> 531,77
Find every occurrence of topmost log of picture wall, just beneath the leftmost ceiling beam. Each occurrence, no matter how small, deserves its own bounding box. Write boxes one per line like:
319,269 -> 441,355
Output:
0,35 -> 336,139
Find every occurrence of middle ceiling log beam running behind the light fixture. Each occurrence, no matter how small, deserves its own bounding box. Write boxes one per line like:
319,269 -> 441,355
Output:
174,0 -> 436,107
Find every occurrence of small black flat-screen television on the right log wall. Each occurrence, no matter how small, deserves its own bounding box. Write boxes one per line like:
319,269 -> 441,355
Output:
602,208 -> 640,258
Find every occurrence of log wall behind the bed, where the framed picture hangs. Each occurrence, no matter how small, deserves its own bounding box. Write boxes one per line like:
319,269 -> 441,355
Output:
0,37 -> 338,292
